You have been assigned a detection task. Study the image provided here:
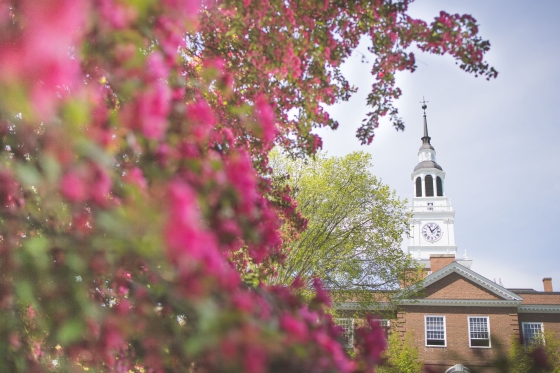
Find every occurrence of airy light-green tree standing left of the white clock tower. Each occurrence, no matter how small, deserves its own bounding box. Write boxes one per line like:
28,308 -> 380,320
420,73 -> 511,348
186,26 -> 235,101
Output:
271,151 -> 415,303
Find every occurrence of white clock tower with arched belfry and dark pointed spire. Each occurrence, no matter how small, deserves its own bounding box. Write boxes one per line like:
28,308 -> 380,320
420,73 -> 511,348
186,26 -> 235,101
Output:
408,101 -> 472,268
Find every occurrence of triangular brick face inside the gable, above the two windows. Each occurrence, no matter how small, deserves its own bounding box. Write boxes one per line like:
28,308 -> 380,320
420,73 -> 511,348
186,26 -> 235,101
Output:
419,272 -> 504,300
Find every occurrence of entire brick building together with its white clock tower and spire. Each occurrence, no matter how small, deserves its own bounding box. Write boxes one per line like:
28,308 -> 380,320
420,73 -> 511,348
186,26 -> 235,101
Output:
339,104 -> 560,373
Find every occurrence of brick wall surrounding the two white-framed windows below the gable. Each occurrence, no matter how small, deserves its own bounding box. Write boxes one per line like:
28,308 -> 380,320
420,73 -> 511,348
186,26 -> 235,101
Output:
397,306 -> 519,372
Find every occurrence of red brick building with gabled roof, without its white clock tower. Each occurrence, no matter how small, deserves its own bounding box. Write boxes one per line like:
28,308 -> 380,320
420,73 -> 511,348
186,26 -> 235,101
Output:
393,254 -> 560,372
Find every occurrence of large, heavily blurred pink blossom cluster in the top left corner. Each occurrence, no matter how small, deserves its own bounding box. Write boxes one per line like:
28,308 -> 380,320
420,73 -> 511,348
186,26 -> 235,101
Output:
0,0 -> 87,117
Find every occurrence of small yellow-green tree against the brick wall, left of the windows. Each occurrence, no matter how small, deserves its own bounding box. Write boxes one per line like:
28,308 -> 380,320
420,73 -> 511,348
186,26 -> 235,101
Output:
377,332 -> 423,373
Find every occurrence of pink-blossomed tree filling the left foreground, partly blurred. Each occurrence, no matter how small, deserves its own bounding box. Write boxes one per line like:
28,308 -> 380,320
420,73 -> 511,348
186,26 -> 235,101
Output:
0,0 -> 496,373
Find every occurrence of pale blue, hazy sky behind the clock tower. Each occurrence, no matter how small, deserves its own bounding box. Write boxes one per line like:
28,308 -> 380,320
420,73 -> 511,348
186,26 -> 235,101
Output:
318,0 -> 560,291
